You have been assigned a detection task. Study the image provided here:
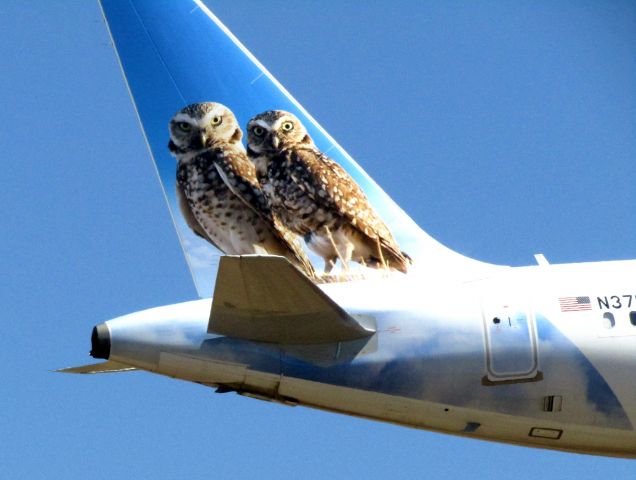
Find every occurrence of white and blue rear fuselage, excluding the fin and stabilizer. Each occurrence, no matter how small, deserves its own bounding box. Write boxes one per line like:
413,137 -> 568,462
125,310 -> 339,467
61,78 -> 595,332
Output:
95,261 -> 636,457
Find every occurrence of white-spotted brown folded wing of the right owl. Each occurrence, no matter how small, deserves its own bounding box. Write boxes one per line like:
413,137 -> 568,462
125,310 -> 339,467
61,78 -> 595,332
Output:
287,148 -> 408,264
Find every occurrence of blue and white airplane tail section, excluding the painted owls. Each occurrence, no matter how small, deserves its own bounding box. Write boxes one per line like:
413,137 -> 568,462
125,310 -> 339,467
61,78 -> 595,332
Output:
62,0 -> 636,458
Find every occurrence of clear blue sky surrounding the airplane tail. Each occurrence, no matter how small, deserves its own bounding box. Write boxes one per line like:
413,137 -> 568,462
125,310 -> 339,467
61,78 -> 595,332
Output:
0,0 -> 636,479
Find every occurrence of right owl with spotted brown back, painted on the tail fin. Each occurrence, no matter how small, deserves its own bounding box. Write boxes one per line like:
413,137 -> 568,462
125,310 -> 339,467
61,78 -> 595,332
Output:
247,110 -> 410,273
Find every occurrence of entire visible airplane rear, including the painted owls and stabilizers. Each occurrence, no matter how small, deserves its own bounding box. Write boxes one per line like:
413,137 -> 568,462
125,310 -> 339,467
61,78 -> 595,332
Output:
62,0 -> 636,457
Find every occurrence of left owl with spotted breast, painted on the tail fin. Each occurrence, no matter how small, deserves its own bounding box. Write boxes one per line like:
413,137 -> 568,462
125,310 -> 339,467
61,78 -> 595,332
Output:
168,102 -> 314,277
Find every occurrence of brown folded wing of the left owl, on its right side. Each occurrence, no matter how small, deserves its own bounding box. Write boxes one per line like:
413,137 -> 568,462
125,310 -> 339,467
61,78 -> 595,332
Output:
214,151 -> 316,278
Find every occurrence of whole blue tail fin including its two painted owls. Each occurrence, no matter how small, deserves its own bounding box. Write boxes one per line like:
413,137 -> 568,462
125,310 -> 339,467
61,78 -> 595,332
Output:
101,0 -> 493,297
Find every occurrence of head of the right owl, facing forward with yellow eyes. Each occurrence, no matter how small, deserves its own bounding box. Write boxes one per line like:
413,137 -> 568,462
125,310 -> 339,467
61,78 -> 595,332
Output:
247,110 -> 313,154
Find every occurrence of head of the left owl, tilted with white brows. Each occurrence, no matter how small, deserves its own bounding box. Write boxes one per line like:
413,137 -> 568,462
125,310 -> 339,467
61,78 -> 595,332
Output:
168,102 -> 243,154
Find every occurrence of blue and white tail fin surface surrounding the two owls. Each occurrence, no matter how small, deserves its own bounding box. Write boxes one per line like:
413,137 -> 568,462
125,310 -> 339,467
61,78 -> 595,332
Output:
101,0 -> 492,296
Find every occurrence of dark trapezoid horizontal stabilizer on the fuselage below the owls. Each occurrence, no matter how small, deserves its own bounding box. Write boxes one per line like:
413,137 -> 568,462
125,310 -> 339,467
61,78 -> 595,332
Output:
208,255 -> 375,345
